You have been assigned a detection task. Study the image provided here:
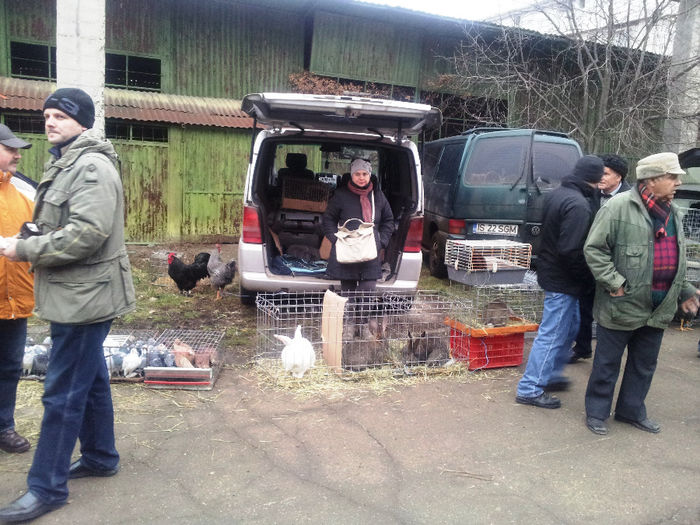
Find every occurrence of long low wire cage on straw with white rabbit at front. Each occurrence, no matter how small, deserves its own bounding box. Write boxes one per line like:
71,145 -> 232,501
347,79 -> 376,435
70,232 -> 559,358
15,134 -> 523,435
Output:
256,291 -> 471,377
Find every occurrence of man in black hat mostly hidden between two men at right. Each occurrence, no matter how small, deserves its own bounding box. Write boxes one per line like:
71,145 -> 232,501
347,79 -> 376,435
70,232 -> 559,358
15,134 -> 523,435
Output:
569,153 -> 631,363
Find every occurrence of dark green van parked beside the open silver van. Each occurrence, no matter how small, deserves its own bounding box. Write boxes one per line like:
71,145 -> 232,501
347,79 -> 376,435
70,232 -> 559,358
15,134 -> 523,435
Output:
422,128 -> 582,277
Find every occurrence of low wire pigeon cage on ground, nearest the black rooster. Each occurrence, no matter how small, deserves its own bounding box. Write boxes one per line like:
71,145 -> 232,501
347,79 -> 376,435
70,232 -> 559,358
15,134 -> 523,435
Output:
144,329 -> 224,390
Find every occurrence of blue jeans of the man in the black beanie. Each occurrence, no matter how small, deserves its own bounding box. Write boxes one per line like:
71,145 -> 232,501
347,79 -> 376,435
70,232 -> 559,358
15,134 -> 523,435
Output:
27,320 -> 119,504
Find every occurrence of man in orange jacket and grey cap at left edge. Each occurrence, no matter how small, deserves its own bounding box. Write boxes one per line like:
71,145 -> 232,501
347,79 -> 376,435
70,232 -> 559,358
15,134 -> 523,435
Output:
0,124 -> 34,452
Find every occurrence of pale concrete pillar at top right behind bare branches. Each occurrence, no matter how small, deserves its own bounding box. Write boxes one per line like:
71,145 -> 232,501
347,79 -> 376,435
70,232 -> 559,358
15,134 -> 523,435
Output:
663,0 -> 700,153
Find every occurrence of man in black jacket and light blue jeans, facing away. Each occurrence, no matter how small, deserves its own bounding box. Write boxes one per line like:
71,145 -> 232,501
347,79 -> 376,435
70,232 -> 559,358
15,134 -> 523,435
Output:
515,155 -> 604,408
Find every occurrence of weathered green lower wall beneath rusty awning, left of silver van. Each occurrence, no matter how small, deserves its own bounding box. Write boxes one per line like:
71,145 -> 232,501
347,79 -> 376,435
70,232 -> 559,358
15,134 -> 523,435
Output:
13,128 -> 250,242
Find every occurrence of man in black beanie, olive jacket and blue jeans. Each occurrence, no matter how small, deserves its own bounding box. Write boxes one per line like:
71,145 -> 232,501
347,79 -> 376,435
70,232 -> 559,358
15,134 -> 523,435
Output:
0,88 -> 135,522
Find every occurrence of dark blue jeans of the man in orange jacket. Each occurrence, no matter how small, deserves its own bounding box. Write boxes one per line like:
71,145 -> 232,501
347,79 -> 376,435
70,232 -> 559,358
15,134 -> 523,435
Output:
0,319 -> 27,432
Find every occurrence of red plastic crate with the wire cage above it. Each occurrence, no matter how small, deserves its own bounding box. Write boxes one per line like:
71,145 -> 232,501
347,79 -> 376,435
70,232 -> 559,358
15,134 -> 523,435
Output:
448,283 -> 544,370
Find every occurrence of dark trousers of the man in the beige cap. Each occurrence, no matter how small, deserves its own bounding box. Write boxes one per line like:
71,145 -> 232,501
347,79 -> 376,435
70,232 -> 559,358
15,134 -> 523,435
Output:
586,325 -> 664,421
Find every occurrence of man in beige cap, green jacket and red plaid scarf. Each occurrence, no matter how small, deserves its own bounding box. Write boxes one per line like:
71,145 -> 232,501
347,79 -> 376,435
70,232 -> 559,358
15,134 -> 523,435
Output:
584,153 -> 699,434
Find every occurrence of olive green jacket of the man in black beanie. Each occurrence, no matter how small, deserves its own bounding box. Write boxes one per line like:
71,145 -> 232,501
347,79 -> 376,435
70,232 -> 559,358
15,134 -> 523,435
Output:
17,130 -> 135,324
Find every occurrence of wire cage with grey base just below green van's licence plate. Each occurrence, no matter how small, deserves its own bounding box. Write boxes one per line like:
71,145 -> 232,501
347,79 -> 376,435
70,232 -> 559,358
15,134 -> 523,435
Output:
445,239 -> 532,285
